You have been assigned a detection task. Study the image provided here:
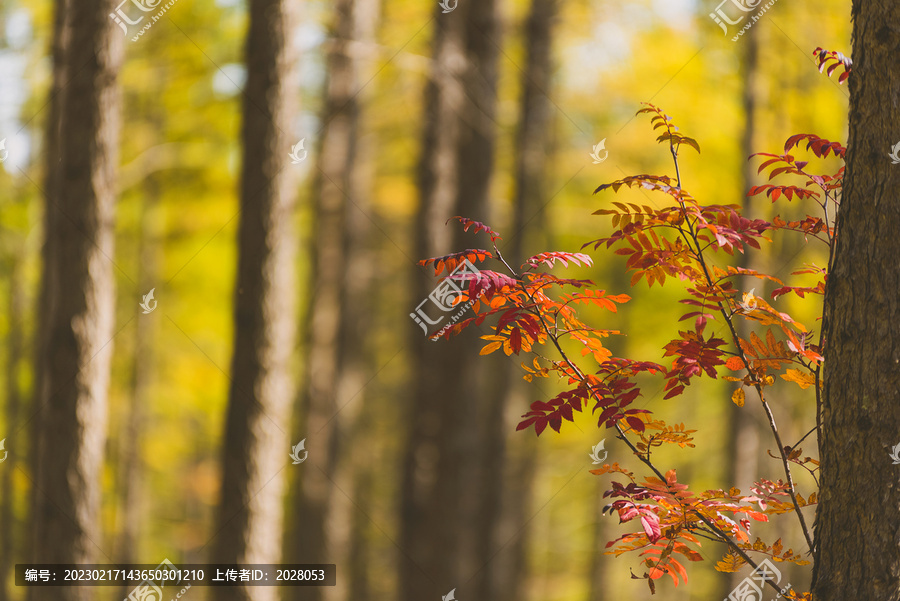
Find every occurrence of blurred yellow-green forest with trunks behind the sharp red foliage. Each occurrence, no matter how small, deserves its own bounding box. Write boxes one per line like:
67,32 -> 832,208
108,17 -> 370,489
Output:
0,0 -> 850,601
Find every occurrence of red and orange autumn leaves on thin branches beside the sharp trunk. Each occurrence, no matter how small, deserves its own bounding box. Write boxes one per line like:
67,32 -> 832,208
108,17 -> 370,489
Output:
420,55 -> 850,599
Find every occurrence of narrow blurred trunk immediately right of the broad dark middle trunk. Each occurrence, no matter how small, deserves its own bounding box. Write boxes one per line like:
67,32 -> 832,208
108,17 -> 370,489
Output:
476,0 -> 559,601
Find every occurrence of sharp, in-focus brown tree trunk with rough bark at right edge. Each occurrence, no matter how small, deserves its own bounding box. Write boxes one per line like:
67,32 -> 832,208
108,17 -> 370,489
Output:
813,0 -> 900,601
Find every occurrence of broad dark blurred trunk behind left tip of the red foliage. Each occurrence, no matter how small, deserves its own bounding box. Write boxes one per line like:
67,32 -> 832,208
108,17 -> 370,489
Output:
399,0 -> 499,601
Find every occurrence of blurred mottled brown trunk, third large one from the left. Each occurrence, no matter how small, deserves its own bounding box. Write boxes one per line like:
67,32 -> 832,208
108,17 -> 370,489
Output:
291,0 -> 379,601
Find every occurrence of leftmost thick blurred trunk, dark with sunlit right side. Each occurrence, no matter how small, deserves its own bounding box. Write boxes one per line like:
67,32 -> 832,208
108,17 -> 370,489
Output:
31,0 -> 122,601
